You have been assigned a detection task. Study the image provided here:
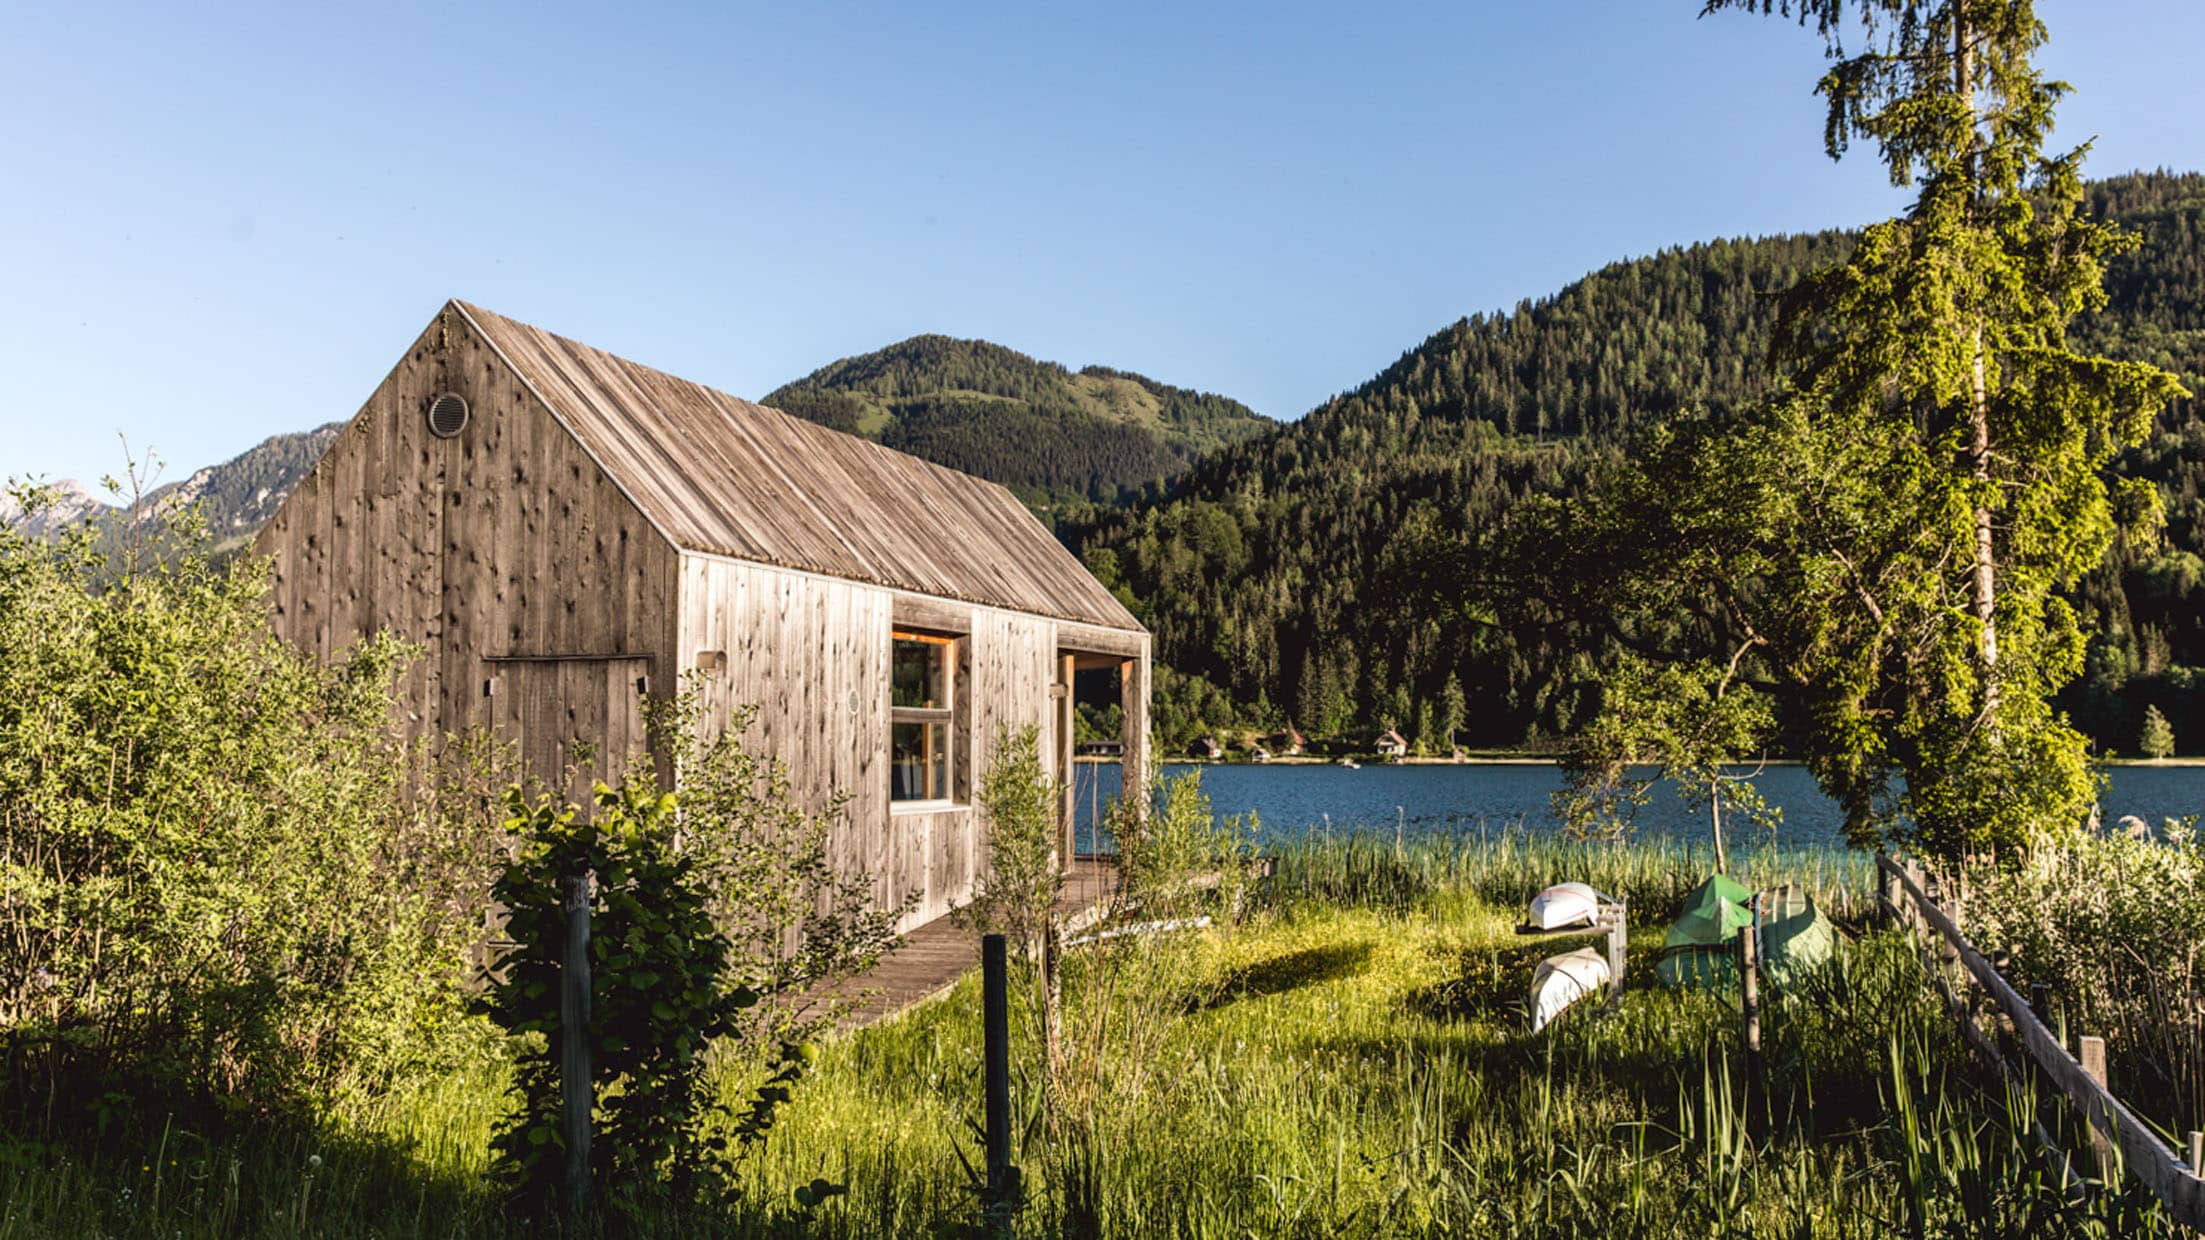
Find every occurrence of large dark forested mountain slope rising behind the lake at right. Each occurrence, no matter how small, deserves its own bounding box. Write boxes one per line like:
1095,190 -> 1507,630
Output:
1069,174 -> 2205,748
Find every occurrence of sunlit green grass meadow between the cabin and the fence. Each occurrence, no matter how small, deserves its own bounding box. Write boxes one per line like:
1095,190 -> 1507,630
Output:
0,838 -> 2163,1240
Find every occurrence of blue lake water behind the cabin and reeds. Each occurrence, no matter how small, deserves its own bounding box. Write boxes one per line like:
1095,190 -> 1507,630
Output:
1076,763 -> 2205,849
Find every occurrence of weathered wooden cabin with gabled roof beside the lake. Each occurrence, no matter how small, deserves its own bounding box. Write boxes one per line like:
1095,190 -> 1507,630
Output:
258,302 -> 1149,927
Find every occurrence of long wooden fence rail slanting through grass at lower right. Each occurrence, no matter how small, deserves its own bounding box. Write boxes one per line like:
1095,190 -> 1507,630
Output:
1876,854 -> 2205,1231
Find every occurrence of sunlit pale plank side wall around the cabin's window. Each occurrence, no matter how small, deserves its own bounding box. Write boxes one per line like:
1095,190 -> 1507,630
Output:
679,556 -> 1056,924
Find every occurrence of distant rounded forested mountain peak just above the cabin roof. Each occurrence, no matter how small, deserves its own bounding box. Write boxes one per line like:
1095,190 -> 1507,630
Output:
761,335 -> 1272,510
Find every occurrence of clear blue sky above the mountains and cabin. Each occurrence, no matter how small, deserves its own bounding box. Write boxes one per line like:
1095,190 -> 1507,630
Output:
0,0 -> 2205,479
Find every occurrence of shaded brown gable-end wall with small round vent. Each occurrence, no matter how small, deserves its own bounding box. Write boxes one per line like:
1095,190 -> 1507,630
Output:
258,309 -> 677,779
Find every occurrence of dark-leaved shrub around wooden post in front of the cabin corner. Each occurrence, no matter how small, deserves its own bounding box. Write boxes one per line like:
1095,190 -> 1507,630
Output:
485,677 -> 902,1209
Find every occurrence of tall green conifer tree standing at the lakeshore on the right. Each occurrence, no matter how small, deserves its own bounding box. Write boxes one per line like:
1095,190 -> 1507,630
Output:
1704,0 -> 2185,854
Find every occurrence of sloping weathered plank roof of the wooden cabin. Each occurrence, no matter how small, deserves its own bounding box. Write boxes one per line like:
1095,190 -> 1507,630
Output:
452,302 -> 1140,631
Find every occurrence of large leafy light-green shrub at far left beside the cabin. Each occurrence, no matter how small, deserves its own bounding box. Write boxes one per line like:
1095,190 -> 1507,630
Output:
0,480 -> 498,1127
